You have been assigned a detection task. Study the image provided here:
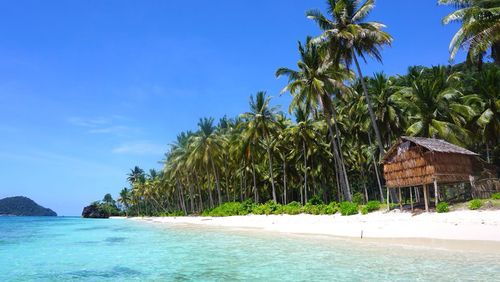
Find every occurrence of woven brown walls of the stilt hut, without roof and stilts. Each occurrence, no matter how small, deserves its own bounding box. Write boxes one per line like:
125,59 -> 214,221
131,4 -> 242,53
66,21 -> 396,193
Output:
384,146 -> 472,188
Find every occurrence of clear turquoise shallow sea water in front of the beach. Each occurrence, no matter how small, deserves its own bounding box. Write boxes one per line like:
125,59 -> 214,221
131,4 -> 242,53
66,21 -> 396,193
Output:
0,217 -> 500,281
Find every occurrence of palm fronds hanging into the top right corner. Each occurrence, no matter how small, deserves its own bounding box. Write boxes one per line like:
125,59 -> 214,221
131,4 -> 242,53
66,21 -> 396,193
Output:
438,0 -> 500,66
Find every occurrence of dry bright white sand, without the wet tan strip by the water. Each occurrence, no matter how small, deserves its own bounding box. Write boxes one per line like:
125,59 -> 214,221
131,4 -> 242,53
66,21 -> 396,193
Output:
128,210 -> 500,244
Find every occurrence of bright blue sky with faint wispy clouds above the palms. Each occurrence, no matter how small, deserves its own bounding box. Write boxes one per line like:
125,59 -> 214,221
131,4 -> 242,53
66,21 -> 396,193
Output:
0,0 -> 463,215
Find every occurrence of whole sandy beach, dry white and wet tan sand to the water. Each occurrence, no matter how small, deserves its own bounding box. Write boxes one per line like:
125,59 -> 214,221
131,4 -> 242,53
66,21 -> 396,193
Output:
128,210 -> 500,253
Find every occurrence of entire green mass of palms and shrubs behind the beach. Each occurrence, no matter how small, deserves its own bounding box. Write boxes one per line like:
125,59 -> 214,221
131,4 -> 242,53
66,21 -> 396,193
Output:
95,0 -> 500,216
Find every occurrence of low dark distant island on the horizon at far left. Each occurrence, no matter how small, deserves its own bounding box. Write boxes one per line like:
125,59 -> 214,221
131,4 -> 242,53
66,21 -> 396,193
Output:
0,196 -> 57,216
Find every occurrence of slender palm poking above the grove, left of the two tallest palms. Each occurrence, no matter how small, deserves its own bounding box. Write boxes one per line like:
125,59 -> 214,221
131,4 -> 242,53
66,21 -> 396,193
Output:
241,91 -> 277,202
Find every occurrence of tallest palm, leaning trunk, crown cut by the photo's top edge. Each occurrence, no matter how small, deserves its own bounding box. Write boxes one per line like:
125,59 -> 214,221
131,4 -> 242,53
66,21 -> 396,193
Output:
306,0 -> 392,154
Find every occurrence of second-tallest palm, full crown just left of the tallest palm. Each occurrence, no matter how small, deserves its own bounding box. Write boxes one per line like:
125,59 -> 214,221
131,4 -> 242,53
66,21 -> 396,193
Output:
276,38 -> 351,201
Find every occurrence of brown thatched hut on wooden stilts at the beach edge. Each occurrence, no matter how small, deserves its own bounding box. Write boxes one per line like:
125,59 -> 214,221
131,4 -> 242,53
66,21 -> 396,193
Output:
382,136 -> 477,211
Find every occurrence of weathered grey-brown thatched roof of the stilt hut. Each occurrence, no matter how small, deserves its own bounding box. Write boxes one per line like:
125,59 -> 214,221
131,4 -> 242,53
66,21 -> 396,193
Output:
382,136 -> 478,162
